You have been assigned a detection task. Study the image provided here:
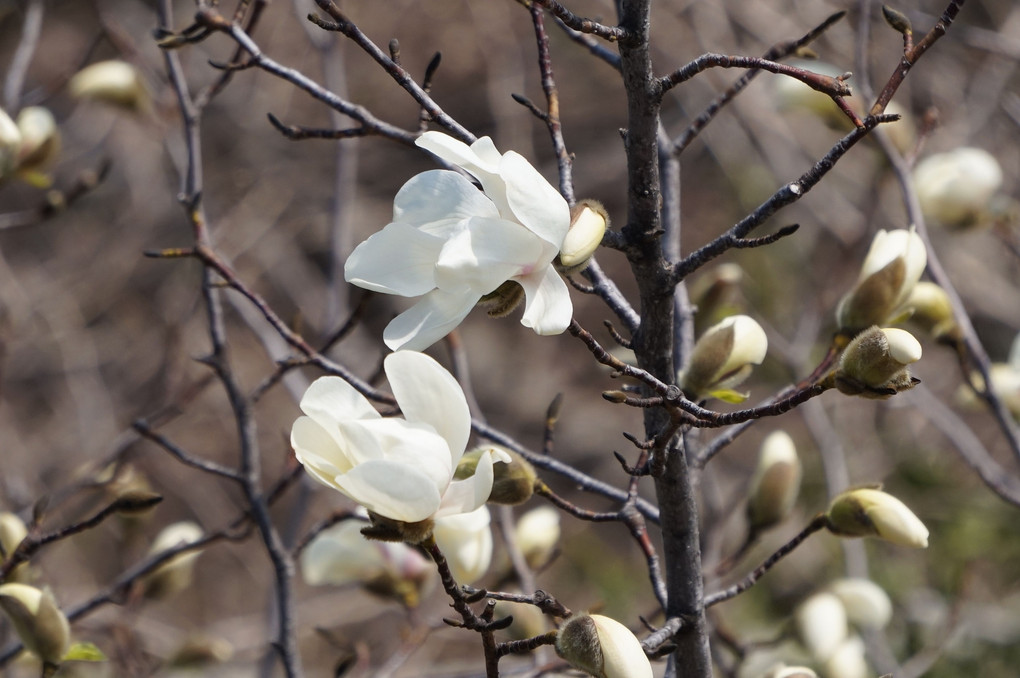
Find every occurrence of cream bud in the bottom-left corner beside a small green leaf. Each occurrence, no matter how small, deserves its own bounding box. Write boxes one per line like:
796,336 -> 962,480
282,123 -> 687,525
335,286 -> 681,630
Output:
0,583 -> 70,666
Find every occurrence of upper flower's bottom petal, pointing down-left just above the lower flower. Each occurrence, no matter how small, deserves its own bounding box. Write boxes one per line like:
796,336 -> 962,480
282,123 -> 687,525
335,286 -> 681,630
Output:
383,290 -> 478,351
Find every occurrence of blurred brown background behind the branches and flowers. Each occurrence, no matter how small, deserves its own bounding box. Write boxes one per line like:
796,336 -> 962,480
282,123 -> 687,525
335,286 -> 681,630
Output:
0,0 -> 1020,678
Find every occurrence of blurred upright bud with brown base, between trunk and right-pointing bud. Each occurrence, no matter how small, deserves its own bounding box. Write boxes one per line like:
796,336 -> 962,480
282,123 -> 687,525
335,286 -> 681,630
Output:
748,431 -> 801,532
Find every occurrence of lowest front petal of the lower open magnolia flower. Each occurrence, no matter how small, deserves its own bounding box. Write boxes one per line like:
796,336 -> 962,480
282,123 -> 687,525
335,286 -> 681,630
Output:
335,460 -> 440,523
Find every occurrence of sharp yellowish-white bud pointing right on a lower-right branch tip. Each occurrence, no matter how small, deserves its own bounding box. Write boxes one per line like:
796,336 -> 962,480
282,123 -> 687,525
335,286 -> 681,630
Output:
825,487 -> 928,549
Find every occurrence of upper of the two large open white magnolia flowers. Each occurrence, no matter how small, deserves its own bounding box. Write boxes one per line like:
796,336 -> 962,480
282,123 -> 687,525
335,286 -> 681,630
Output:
344,132 -> 572,351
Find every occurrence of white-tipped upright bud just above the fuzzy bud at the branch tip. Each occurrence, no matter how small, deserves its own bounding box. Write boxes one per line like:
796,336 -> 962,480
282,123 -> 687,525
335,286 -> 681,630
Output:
836,228 -> 928,336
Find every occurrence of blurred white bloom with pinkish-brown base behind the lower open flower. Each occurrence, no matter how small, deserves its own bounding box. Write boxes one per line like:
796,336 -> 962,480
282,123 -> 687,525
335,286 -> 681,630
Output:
300,513 -> 435,608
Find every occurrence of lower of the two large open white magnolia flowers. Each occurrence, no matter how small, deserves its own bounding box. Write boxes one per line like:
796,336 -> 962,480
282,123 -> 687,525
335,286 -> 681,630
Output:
291,351 -> 506,523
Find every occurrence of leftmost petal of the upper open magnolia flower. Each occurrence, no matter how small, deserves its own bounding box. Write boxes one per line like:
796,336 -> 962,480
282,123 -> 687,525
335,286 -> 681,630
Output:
344,221 -> 444,297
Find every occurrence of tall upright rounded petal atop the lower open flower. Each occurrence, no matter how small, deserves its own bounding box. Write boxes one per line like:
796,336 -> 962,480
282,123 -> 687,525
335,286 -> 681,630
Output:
384,351 -> 471,465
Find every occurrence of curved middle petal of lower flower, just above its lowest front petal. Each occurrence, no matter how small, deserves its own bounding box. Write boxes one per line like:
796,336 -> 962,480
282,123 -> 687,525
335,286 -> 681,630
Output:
341,418 -> 454,492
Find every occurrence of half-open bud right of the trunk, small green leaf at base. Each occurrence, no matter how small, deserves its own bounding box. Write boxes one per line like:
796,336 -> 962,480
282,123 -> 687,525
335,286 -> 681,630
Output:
679,315 -> 768,402
